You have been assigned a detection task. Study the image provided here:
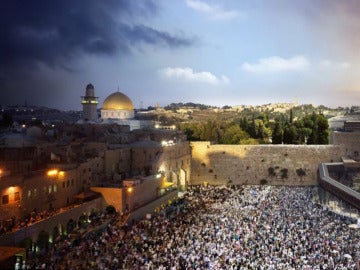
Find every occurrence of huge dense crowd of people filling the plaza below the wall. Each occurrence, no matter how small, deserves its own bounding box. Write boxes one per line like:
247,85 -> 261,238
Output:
26,186 -> 360,270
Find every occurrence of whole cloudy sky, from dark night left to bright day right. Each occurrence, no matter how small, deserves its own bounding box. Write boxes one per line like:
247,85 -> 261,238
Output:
0,0 -> 360,110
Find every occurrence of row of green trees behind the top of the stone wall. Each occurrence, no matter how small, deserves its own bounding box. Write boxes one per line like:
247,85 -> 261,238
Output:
178,110 -> 329,144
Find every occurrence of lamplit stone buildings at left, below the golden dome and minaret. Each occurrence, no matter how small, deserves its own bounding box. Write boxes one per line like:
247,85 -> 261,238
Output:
0,120 -> 191,240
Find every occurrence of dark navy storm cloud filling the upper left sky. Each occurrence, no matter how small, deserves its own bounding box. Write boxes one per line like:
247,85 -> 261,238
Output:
0,0 -> 192,69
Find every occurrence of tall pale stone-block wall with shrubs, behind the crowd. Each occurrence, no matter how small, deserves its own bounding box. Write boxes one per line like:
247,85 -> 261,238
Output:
190,142 -> 344,185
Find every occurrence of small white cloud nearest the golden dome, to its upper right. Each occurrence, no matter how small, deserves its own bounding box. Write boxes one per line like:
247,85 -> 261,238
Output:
160,67 -> 230,85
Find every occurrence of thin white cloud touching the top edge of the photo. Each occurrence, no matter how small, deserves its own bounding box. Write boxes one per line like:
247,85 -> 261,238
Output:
186,0 -> 240,20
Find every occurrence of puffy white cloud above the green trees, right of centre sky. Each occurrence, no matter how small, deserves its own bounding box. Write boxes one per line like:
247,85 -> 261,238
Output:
241,55 -> 310,73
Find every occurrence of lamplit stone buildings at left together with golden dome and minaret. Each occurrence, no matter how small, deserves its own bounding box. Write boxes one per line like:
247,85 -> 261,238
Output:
0,84 -> 191,248
